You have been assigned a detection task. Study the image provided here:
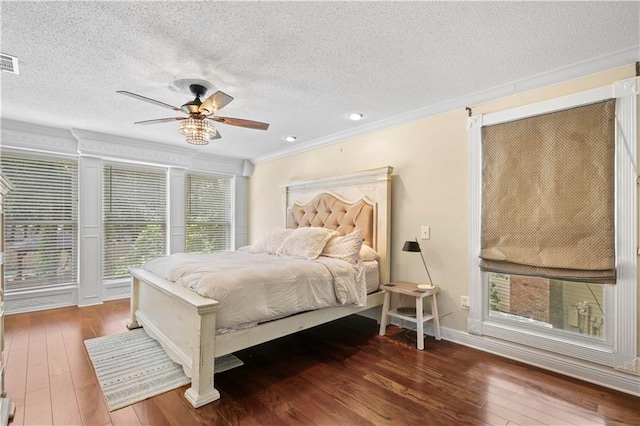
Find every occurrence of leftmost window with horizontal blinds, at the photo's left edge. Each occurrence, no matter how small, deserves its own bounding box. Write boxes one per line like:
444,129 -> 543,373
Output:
2,153 -> 78,291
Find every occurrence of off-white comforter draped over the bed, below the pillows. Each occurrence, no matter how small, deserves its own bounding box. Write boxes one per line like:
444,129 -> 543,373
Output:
144,251 -> 366,332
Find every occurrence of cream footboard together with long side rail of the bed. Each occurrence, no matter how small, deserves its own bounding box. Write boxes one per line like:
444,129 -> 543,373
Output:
127,269 -> 384,408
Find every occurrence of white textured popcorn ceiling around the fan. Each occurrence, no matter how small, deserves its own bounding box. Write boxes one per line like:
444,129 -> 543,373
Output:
0,1 -> 640,160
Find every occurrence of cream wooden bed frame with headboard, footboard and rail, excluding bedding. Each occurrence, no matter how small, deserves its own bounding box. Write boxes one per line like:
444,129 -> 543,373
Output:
127,167 -> 393,407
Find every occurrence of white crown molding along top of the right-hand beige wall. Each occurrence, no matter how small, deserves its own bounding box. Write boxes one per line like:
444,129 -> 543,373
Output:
251,45 -> 640,164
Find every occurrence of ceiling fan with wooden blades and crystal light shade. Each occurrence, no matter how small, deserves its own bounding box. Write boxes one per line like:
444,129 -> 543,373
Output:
117,84 -> 269,145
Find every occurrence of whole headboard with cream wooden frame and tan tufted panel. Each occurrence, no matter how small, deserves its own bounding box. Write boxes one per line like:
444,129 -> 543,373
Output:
281,166 -> 393,284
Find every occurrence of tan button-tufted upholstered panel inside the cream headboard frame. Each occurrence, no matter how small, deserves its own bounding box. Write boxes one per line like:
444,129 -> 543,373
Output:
287,193 -> 375,247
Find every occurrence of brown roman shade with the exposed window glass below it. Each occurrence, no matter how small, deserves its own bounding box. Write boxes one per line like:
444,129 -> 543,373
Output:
480,99 -> 615,338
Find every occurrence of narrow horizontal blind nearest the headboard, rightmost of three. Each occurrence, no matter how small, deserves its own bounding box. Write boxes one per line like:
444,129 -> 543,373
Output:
185,173 -> 232,253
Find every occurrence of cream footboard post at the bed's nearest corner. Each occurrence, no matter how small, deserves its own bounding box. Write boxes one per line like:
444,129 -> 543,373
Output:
184,305 -> 220,408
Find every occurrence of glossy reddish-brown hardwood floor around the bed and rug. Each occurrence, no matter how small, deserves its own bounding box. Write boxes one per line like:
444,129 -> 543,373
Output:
5,300 -> 640,426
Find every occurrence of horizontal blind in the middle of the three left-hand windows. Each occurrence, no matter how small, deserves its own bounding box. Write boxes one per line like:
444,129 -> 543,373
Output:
102,164 -> 167,280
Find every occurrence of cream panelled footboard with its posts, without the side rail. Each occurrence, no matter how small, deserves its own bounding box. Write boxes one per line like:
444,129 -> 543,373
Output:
127,268 -> 220,408
